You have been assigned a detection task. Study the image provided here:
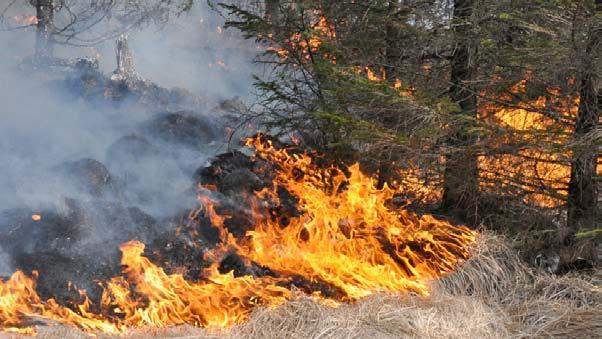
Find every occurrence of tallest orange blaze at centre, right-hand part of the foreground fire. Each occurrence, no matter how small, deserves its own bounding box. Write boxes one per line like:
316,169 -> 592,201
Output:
230,139 -> 475,300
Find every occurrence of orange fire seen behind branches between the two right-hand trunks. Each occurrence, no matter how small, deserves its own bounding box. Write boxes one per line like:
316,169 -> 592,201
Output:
479,73 -> 579,207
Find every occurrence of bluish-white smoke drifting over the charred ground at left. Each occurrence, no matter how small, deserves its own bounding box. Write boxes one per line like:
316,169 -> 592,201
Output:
0,4 -> 256,275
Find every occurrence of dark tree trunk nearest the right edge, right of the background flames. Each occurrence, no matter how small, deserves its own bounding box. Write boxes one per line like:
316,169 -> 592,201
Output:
560,3 -> 602,245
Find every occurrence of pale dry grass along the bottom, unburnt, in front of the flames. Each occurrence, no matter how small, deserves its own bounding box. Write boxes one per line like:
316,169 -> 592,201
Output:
19,234 -> 602,338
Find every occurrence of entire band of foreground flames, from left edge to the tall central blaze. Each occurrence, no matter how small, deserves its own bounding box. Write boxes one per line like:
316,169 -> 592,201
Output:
0,137 -> 476,334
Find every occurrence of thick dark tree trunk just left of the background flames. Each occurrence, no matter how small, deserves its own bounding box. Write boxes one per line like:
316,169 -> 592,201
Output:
442,0 -> 478,224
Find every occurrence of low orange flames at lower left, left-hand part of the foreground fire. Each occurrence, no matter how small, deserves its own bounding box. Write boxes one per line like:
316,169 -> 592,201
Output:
0,241 -> 291,334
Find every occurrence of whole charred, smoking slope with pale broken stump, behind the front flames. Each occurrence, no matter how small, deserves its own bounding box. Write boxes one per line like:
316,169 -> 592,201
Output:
0,32 -> 318,314
